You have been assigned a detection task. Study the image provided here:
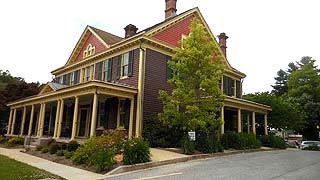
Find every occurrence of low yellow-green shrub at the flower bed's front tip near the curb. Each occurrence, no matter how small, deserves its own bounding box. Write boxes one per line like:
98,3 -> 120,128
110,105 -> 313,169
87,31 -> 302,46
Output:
90,148 -> 114,172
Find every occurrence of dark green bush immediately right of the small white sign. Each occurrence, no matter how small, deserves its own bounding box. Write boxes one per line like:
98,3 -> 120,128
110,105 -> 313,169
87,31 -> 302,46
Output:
196,134 -> 223,153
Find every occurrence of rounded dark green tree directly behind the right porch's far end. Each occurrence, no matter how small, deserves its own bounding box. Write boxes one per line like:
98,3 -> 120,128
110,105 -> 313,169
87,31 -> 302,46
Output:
243,92 -> 305,130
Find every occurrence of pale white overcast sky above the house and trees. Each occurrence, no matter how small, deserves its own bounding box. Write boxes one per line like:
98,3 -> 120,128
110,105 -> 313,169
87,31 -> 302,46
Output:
0,0 -> 320,94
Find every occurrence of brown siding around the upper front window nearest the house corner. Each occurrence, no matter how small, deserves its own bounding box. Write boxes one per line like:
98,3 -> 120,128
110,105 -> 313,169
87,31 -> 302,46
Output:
112,49 -> 139,88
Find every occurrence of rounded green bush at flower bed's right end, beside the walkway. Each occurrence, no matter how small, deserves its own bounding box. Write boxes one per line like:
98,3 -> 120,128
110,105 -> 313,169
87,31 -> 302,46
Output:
123,138 -> 150,165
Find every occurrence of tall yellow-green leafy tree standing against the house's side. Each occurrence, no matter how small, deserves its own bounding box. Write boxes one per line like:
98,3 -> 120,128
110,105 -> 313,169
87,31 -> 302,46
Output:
158,20 -> 223,132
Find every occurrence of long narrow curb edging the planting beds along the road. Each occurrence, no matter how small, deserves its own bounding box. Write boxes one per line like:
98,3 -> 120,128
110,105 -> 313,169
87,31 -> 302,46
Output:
105,149 -> 280,176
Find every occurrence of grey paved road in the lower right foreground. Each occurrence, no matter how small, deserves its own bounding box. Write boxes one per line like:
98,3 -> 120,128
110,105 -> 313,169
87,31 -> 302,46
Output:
106,150 -> 320,180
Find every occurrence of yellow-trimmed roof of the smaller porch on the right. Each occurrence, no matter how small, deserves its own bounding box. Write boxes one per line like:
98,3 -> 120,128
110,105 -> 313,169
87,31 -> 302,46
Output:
223,96 -> 272,114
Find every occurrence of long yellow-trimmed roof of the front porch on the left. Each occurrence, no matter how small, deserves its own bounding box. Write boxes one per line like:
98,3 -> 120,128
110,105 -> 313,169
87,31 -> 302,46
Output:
7,80 -> 138,107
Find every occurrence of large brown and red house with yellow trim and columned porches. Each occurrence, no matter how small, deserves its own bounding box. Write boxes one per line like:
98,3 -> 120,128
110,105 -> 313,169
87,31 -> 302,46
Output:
7,0 -> 271,143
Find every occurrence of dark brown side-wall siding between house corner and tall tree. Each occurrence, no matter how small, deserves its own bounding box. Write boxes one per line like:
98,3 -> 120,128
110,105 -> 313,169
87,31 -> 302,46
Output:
143,49 -> 172,126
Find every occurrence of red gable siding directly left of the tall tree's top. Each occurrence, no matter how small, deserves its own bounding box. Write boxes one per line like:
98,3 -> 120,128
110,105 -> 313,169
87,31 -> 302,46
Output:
153,16 -> 193,47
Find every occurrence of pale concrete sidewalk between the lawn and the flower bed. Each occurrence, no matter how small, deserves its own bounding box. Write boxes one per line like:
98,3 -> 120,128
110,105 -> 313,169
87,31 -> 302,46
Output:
0,147 -> 104,180
